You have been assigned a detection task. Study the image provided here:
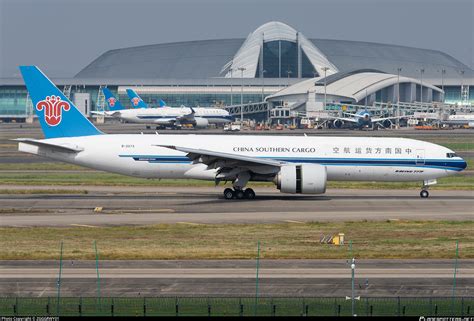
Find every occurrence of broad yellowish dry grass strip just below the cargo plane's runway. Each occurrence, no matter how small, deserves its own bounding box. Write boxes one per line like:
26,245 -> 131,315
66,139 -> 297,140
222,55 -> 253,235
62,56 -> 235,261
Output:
0,221 -> 474,260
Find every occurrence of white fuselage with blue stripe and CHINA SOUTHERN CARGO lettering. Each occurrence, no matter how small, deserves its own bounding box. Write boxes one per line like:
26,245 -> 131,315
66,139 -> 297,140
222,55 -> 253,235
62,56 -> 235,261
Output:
19,135 -> 466,182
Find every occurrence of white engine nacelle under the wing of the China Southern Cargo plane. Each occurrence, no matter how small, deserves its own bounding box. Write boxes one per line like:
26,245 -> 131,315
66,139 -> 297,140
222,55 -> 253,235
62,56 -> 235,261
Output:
276,164 -> 327,194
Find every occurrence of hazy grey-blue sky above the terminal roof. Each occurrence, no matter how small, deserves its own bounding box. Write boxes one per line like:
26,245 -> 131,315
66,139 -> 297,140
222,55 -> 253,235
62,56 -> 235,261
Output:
0,0 -> 474,77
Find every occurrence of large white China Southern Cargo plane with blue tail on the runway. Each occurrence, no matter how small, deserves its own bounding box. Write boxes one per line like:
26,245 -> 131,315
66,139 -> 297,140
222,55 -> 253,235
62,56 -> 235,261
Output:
17,66 -> 466,199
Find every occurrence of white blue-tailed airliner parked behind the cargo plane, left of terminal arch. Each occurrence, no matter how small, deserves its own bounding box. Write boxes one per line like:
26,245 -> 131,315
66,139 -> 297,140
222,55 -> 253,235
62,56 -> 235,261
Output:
100,88 -> 233,128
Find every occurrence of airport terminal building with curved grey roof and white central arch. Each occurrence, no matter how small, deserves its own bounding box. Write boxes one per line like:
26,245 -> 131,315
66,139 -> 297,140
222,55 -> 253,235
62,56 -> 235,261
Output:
0,21 -> 474,120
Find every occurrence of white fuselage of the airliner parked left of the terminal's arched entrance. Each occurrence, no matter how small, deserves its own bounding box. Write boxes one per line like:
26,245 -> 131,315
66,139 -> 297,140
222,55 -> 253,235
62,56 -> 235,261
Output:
108,107 -> 232,125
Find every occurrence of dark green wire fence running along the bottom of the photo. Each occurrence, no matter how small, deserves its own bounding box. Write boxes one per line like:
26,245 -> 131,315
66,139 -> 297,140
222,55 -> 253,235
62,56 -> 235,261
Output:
0,297 -> 474,317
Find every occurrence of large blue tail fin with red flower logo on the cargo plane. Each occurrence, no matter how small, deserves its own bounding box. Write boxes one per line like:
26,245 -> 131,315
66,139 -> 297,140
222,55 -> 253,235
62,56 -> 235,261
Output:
20,66 -> 102,138
